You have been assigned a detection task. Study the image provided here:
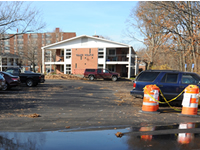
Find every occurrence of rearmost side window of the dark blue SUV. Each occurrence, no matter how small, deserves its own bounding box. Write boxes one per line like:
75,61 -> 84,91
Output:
136,72 -> 159,82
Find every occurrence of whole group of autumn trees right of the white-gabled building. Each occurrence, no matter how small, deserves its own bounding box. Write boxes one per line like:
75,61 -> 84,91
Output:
127,1 -> 200,72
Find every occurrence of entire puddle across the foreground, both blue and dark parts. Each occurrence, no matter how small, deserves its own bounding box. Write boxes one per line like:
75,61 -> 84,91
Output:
0,123 -> 200,150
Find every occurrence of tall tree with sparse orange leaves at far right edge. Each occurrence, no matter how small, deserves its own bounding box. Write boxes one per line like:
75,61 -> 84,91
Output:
150,1 -> 200,71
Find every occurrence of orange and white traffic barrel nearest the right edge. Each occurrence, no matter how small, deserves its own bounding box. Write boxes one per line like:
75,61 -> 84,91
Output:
181,85 -> 199,116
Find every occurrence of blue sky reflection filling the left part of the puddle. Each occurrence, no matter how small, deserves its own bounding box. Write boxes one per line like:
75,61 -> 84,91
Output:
0,129 -> 128,150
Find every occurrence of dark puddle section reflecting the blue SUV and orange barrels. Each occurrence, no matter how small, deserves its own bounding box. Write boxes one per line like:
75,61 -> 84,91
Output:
126,123 -> 200,150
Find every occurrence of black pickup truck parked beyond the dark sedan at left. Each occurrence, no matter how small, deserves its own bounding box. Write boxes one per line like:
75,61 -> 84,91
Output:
6,68 -> 45,87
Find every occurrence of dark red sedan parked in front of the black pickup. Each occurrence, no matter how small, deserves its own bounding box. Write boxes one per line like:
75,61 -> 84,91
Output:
0,71 -> 21,91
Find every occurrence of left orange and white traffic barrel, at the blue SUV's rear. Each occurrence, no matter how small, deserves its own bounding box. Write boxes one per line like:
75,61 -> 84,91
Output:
141,85 -> 159,113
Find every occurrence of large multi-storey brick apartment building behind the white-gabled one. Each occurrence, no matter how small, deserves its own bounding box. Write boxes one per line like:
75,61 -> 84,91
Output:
0,28 -> 76,72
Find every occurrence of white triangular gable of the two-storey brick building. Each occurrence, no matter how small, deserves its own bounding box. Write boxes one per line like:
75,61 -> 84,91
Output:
42,35 -> 131,49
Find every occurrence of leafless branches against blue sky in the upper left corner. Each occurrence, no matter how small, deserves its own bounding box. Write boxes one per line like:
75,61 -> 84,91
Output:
0,1 -> 45,40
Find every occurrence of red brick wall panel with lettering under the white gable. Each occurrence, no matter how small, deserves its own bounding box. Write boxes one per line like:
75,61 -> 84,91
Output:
71,48 -> 98,74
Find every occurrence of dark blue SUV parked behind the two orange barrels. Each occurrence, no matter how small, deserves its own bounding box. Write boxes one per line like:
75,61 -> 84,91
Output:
130,70 -> 200,100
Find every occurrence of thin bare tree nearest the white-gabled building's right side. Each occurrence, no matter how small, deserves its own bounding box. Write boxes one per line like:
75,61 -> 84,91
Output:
126,2 -> 168,69
